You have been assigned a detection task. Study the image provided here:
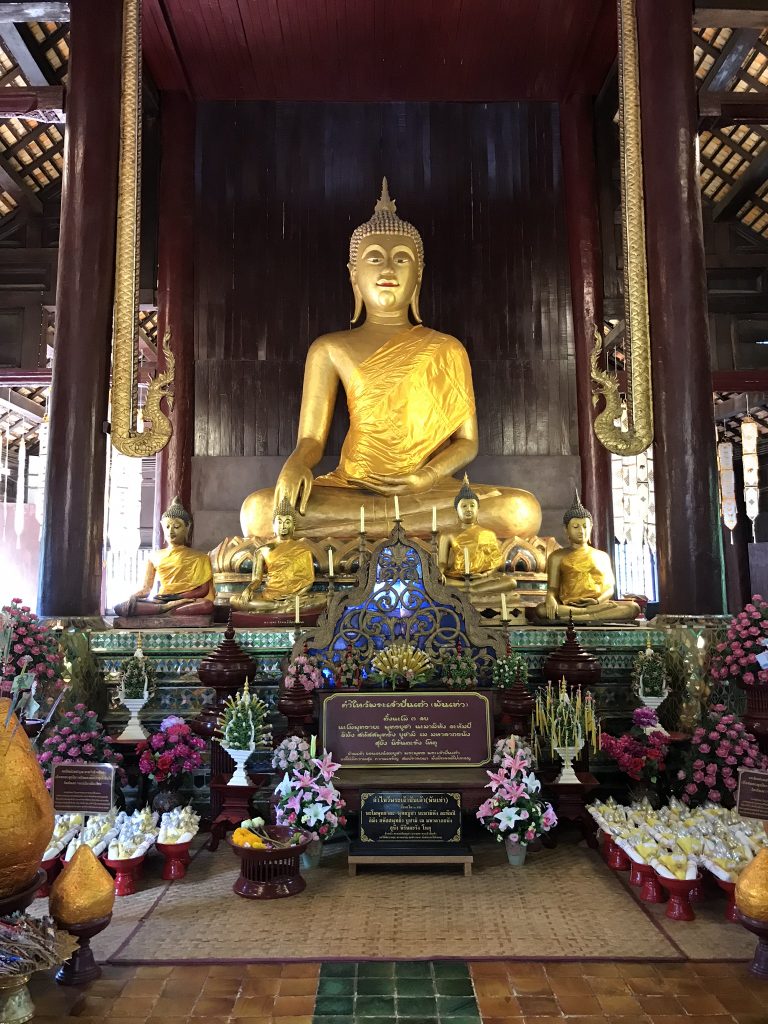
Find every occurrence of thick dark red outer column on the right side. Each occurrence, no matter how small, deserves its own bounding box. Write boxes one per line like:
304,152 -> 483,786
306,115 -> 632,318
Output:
637,0 -> 723,614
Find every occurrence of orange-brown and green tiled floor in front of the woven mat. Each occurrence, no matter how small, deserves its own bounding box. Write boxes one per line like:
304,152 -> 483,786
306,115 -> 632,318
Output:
31,958 -> 768,1024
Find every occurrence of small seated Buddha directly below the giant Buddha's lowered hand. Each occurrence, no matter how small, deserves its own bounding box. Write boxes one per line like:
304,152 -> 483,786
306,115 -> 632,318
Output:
229,498 -> 325,618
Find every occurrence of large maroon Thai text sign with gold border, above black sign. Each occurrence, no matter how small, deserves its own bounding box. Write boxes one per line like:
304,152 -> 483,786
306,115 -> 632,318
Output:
322,691 -> 492,768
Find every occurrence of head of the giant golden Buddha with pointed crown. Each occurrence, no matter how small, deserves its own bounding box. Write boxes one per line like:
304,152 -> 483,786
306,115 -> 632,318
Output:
347,178 -> 424,324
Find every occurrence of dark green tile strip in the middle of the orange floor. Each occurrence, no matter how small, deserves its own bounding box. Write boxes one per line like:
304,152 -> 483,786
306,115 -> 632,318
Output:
312,961 -> 480,1024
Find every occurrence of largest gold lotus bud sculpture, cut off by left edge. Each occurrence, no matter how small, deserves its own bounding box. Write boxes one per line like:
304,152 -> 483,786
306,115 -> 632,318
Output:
0,697 -> 53,898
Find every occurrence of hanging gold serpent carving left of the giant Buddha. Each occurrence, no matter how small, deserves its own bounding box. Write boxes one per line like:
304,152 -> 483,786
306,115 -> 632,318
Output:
111,0 -> 174,458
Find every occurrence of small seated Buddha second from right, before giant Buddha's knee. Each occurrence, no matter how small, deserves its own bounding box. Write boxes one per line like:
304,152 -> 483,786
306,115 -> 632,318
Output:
437,474 -> 516,610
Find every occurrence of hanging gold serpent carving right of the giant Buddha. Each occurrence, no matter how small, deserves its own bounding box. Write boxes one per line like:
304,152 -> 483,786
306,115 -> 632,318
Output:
591,0 -> 653,456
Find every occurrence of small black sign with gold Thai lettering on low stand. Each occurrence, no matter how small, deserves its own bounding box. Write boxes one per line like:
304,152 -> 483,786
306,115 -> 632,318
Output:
360,790 -> 462,846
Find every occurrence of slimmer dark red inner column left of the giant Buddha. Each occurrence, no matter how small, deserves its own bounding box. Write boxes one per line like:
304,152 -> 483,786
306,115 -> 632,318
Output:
155,92 -> 195,544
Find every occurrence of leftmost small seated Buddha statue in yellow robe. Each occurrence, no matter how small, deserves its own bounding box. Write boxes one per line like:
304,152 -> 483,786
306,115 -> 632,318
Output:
115,498 -> 215,617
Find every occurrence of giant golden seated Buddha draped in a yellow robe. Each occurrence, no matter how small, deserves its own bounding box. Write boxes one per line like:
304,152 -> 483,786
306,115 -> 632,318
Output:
241,178 -> 542,539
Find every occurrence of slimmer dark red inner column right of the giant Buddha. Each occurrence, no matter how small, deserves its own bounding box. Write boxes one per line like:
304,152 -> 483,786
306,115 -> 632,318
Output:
560,96 -> 613,558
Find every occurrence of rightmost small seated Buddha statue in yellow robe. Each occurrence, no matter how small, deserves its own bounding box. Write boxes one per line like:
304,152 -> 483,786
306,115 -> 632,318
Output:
534,494 -> 640,624
